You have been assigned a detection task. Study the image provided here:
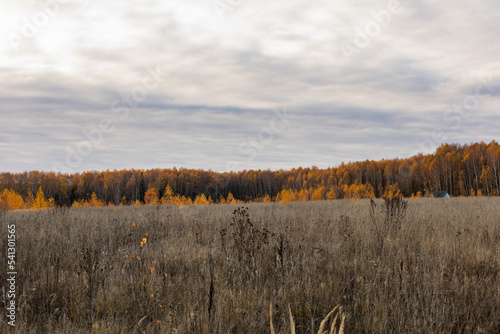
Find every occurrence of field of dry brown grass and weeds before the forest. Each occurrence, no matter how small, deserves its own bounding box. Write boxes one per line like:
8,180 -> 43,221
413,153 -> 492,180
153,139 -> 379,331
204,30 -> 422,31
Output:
0,198 -> 500,334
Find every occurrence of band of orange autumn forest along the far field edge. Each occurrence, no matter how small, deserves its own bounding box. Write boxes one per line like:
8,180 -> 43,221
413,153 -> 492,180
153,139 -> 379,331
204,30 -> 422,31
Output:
0,141 -> 500,209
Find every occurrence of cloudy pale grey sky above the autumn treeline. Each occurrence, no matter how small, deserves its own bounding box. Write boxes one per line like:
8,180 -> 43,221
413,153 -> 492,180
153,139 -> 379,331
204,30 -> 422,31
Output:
0,0 -> 500,173
